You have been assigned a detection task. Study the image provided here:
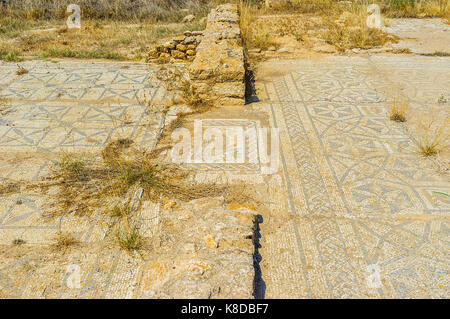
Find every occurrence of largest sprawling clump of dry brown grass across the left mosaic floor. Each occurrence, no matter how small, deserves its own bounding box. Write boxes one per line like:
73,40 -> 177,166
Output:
42,139 -> 229,216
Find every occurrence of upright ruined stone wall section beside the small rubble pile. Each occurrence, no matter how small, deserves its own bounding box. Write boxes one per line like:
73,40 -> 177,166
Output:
189,4 -> 245,106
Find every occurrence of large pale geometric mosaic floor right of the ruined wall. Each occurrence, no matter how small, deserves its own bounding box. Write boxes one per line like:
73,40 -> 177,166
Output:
257,56 -> 450,298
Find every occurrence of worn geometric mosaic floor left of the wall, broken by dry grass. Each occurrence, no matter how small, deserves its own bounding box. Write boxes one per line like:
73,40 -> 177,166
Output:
0,61 -> 166,298
